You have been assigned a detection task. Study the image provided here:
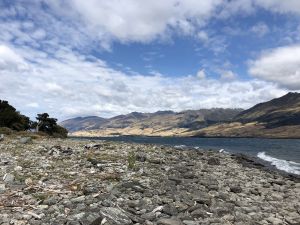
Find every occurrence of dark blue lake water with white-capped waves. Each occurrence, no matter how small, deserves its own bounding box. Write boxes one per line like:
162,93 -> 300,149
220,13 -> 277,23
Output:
72,136 -> 300,175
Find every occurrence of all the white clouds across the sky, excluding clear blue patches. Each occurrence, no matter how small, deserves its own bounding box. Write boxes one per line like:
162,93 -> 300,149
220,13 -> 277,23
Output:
0,0 -> 300,119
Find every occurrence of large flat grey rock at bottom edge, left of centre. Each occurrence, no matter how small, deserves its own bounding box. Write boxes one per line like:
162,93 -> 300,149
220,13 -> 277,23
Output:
100,207 -> 133,225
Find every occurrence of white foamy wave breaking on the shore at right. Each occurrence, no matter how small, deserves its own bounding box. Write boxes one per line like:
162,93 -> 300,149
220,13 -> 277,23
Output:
257,152 -> 300,175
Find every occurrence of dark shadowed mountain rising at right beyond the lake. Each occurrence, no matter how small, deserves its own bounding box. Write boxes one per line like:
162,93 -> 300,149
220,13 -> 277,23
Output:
196,92 -> 300,138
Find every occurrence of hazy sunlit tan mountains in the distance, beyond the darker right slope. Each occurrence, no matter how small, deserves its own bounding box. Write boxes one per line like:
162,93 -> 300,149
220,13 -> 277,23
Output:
60,108 -> 242,135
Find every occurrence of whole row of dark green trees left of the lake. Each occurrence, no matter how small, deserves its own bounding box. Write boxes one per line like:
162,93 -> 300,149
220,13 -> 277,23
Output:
0,100 -> 68,137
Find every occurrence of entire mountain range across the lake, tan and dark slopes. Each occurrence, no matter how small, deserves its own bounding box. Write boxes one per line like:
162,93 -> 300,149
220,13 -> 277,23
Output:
60,93 -> 300,138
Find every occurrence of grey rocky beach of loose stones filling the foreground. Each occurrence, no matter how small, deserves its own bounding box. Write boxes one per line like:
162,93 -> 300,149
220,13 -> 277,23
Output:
0,137 -> 300,225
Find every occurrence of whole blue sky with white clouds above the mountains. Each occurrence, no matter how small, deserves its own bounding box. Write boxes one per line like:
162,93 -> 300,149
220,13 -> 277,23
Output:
0,0 -> 300,120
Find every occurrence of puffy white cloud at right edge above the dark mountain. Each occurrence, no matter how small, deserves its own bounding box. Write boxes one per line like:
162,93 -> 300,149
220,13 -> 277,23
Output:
249,45 -> 300,90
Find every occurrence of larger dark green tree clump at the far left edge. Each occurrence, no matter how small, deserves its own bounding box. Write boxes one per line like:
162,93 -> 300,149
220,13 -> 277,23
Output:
0,100 -> 31,131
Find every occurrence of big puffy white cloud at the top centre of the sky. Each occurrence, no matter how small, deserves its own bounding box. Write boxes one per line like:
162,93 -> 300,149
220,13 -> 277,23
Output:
63,0 -> 222,42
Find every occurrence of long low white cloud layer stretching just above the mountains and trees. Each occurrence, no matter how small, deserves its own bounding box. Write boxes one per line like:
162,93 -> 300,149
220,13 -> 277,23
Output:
0,41 -> 286,119
